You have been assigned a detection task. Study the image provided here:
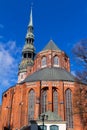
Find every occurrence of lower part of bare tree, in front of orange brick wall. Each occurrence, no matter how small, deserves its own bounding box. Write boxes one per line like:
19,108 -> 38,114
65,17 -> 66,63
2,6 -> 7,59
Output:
73,83 -> 87,130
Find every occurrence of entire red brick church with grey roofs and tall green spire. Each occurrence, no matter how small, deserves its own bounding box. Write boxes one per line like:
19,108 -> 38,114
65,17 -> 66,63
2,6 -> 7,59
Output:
0,9 -> 87,130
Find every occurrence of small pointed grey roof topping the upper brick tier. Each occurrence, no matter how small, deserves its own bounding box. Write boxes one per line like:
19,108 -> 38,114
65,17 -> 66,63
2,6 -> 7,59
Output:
42,40 -> 61,51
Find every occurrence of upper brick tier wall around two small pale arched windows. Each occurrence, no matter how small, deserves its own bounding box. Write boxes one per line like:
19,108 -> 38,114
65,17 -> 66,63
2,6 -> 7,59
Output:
31,50 -> 70,73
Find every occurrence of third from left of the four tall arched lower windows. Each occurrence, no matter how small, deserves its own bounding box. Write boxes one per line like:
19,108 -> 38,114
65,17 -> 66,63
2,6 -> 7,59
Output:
53,89 -> 58,113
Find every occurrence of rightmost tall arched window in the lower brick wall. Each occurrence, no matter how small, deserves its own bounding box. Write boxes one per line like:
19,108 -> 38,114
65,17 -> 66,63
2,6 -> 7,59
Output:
65,89 -> 73,128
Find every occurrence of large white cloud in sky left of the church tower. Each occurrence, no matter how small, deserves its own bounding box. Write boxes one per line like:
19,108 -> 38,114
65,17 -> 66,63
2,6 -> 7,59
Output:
0,41 -> 21,102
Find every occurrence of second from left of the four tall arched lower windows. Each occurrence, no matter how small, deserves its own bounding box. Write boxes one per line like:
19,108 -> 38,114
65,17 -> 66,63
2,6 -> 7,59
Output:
41,90 -> 47,113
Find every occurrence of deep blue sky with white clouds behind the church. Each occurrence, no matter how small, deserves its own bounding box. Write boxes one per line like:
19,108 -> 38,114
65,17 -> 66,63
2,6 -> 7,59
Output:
0,0 -> 87,104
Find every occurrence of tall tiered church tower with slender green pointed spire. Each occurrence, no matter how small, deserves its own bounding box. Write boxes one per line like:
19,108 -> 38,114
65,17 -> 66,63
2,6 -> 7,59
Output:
18,8 -> 35,83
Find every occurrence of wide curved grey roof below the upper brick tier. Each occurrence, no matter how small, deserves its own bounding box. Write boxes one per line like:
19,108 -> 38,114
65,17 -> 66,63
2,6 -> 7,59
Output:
23,67 -> 75,82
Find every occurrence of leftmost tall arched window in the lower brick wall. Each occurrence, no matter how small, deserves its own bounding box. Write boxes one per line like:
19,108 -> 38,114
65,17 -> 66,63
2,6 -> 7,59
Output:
28,90 -> 35,121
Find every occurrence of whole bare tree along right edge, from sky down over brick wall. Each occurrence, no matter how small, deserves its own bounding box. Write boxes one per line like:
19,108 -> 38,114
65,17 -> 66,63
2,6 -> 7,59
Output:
73,39 -> 87,130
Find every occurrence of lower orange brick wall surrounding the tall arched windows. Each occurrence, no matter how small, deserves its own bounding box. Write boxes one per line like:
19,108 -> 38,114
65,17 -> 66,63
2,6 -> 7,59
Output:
2,81 -> 85,130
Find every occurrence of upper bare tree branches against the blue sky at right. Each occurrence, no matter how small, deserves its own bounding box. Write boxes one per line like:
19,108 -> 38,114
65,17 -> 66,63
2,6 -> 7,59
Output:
73,39 -> 87,82
